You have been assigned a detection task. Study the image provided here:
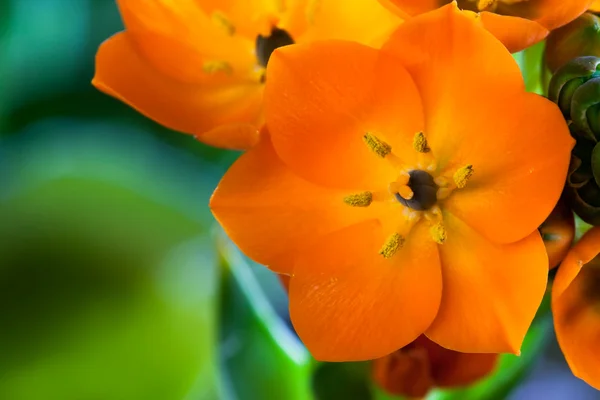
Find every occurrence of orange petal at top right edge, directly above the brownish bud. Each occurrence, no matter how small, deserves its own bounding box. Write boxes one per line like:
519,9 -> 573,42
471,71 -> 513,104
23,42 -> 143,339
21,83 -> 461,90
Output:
531,0 -> 593,30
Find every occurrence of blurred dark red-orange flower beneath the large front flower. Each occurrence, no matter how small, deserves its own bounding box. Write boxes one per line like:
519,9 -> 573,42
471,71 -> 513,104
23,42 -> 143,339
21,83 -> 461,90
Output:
373,336 -> 498,398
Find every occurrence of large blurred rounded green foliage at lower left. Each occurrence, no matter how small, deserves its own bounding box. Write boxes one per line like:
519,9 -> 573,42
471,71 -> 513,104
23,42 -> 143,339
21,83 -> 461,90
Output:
0,120 -> 224,400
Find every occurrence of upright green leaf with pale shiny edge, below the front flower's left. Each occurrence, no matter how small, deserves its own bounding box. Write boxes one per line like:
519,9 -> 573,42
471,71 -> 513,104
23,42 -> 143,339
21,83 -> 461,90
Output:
221,238 -> 313,400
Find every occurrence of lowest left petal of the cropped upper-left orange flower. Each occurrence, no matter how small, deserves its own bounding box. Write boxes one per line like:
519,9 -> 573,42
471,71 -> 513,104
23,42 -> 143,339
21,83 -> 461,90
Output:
92,33 -> 262,149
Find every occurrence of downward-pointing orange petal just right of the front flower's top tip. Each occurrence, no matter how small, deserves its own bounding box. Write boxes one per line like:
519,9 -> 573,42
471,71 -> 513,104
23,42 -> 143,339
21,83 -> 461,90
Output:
480,11 -> 550,53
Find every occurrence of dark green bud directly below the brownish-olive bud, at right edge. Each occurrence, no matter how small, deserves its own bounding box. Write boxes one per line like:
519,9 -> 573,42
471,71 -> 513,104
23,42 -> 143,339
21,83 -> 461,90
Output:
548,56 -> 600,120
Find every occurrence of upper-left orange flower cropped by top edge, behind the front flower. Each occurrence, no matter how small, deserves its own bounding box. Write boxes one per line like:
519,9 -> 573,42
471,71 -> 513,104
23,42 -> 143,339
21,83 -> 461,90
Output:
92,0 -> 401,149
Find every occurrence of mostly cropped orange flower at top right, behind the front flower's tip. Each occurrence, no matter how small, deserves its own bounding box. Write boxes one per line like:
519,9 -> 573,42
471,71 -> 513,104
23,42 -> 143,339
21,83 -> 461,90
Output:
379,0 -> 592,52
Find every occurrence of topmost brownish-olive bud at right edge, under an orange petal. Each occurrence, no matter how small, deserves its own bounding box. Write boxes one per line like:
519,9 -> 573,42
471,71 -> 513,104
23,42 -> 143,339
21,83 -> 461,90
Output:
544,12 -> 600,73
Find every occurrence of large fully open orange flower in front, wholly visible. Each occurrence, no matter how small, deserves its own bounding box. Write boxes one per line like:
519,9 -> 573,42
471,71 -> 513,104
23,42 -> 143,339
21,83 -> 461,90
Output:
211,5 -> 573,361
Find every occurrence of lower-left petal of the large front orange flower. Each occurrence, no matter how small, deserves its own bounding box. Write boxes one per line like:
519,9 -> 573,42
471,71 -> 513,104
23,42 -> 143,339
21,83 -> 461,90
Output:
290,221 -> 442,361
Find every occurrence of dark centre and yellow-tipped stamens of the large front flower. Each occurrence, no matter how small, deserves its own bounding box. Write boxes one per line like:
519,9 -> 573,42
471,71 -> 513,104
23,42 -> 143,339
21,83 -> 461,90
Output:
344,132 -> 474,258
